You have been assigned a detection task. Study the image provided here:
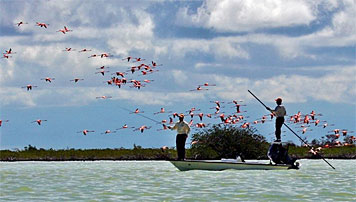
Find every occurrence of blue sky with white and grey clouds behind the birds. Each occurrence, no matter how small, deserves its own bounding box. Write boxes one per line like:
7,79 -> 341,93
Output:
0,0 -> 356,149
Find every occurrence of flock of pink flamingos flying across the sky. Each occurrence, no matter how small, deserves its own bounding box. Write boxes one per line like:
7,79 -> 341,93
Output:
0,21 -> 355,150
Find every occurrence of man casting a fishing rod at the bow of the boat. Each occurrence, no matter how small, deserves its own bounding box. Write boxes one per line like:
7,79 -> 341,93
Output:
168,114 -> 190,161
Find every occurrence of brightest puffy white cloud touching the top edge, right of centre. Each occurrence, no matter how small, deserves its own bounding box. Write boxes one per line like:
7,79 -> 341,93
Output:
177,0 -> 316,32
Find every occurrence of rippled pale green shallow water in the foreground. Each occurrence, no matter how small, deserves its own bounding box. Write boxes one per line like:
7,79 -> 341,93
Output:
0,160 -> 356,201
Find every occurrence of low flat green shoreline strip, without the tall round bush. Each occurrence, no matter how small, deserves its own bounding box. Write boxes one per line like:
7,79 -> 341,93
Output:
0,146 -> 356,162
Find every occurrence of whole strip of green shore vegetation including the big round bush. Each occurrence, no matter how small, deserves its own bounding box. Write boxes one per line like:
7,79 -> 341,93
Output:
0,125 -> 356,161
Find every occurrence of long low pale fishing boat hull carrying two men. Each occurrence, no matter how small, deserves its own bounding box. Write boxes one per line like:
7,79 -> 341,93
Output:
170,159 -> 299,171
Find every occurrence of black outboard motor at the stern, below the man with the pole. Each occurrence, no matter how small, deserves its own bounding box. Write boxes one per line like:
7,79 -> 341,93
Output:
267,142 -> 296,165
